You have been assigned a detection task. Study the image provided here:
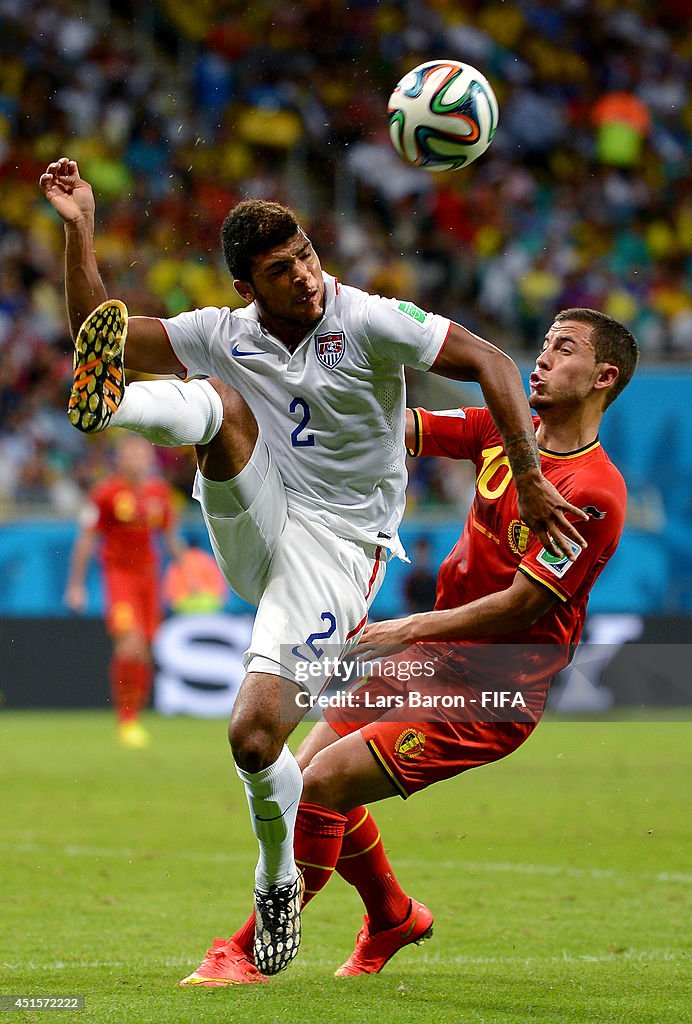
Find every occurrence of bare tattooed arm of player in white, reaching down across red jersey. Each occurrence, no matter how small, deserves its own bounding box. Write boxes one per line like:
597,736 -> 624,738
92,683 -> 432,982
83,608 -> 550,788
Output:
431,324 -> 589,560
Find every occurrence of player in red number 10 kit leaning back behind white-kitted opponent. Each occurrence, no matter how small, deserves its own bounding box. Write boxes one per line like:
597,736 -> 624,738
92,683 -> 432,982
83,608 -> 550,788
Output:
181,309 -> 638,985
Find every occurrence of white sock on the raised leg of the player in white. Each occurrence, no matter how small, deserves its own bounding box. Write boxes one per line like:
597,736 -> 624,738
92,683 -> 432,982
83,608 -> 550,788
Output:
111,380 -> 223,447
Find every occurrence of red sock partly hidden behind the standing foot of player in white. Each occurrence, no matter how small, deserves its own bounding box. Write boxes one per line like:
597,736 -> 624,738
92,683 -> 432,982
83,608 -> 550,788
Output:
231,803 -> 348,956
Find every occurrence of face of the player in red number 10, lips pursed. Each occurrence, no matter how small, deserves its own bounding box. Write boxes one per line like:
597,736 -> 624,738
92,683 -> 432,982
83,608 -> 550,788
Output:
528,321 -> 600,414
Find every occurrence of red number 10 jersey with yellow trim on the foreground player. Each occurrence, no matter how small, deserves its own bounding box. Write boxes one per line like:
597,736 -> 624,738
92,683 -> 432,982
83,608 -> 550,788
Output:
413,409 -> 626,667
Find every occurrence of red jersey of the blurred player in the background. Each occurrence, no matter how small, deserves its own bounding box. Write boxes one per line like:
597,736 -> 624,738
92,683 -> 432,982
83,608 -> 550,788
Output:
87,476 -> 175,572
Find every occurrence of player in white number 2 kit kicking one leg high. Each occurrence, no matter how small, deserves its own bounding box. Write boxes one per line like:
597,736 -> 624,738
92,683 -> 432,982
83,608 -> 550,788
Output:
41,158 -> 585,984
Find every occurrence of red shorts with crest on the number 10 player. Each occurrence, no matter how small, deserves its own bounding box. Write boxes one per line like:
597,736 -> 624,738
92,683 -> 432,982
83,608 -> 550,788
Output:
325,644 -> 550,799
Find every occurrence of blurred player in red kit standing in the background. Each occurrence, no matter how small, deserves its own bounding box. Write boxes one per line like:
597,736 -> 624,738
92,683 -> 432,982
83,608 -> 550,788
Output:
66,435 -> 182,748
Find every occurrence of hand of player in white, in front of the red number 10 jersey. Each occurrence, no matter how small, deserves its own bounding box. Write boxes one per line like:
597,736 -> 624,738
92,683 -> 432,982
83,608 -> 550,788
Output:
515,470 -> 589,562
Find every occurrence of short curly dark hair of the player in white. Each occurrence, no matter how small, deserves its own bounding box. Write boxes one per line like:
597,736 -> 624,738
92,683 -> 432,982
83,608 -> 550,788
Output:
221,199 -> 300,281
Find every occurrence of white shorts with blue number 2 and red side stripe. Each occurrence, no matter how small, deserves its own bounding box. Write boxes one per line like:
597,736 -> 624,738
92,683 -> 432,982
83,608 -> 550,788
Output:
192,438 -> 388,694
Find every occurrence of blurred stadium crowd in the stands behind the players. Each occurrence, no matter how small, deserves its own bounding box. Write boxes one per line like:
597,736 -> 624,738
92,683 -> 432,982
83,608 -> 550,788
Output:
0,0 -> 692,515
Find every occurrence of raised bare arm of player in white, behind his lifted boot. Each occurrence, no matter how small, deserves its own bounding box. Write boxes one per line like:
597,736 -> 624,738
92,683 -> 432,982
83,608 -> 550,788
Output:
39,157 -> 182,374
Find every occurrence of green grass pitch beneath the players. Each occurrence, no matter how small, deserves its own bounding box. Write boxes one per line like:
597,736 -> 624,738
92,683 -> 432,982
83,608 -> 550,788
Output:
0,712 -> 690,1024
